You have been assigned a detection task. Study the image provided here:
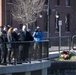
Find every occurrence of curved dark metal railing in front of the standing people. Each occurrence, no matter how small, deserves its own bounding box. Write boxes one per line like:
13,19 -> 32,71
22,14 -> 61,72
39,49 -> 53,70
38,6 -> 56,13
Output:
0,40 -> 49,64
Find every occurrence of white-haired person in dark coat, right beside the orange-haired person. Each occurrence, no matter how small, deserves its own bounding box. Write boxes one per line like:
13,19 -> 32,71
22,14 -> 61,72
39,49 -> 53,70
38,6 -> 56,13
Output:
12,28 -> 19,61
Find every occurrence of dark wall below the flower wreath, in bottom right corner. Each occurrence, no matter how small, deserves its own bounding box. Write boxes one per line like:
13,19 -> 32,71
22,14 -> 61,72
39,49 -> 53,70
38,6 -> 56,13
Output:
48,61 -> 76,75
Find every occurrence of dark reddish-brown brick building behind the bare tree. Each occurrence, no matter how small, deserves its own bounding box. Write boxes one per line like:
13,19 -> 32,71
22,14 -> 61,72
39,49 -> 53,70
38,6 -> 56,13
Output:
0,0 -> 76,37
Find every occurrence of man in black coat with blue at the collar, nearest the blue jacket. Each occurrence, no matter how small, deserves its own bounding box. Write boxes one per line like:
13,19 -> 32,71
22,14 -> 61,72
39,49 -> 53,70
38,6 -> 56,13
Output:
19,25 -> 34,61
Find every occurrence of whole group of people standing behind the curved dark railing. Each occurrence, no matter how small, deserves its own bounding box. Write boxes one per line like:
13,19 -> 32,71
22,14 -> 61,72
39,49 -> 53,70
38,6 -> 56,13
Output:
0,25 -> 43,63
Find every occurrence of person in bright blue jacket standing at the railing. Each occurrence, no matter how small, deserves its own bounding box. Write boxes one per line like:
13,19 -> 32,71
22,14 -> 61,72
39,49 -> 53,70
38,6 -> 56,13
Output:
33,26 -> 44,59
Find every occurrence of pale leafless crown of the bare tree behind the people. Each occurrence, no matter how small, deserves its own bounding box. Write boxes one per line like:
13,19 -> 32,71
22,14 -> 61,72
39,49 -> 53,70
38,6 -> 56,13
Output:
12,0 -> 45,24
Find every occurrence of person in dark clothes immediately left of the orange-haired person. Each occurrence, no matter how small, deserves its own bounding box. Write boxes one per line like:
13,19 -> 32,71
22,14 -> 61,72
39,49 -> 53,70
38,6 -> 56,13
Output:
1,26 -> 8,64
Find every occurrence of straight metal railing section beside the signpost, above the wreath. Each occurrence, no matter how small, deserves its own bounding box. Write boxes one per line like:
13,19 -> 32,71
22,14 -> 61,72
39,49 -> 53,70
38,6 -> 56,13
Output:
44,36 -> 72,52
